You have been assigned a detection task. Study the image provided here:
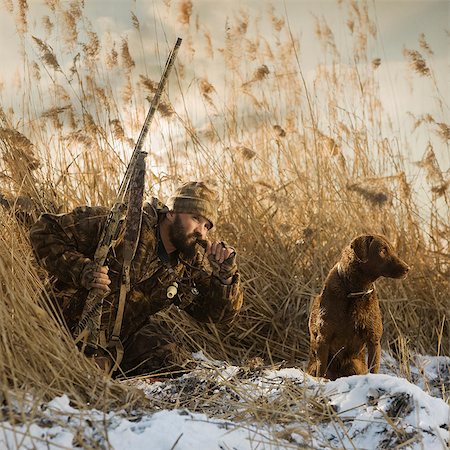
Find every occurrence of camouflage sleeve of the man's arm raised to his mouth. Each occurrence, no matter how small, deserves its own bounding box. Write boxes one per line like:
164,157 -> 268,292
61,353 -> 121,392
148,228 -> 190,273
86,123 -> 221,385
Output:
185,253 -> 244,323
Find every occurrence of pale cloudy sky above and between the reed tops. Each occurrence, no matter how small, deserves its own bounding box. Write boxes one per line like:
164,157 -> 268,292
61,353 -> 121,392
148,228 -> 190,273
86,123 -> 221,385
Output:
0,0 -> 450,170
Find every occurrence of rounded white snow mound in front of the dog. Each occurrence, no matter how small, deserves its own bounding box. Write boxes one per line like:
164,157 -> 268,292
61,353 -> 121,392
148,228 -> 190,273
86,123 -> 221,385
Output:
323,374 -> 450,450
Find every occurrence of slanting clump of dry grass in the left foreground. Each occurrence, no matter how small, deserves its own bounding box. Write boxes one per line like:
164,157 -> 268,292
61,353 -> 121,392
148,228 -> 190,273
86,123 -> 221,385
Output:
0,210 -> 142,408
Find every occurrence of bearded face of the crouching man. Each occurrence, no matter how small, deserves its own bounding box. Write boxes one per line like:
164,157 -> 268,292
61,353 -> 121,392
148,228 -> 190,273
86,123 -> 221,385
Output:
169,213 -> 211,258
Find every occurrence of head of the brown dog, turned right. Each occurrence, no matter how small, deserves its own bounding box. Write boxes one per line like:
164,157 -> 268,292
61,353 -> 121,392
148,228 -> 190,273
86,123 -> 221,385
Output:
350,234 -> 409,278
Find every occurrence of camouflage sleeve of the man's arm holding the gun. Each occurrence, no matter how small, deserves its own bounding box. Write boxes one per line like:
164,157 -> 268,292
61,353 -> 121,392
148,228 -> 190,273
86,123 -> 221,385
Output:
30,206 -> 109,287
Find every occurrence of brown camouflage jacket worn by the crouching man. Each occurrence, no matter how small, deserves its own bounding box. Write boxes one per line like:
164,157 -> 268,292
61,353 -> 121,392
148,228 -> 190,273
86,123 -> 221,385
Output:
30,199 -> 243,341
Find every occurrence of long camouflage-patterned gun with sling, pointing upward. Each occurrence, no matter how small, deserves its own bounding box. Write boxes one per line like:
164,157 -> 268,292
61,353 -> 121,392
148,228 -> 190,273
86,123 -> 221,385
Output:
74,38 -> 181,356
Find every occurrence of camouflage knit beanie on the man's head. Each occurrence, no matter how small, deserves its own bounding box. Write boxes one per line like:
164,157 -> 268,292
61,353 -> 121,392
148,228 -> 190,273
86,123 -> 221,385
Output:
167,181 -> 217,226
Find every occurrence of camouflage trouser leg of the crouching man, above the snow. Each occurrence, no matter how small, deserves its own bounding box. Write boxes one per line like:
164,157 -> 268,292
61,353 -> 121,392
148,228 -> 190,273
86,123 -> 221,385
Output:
120,321 -> 193,376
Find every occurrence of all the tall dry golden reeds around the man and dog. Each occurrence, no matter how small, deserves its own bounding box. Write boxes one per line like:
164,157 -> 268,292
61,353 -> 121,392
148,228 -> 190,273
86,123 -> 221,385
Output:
0,1 -> 450,418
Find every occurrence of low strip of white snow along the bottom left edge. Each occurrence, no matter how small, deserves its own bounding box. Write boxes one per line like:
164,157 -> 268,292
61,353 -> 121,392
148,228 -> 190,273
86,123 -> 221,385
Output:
0,396 -> 285,450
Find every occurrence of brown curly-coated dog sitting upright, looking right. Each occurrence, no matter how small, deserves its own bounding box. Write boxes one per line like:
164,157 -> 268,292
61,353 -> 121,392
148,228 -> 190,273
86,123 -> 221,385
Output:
307,235 -> 409,380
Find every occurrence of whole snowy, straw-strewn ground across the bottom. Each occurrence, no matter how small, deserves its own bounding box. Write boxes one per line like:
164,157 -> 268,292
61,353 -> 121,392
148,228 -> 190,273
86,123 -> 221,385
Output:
0,354 -> 450,450
